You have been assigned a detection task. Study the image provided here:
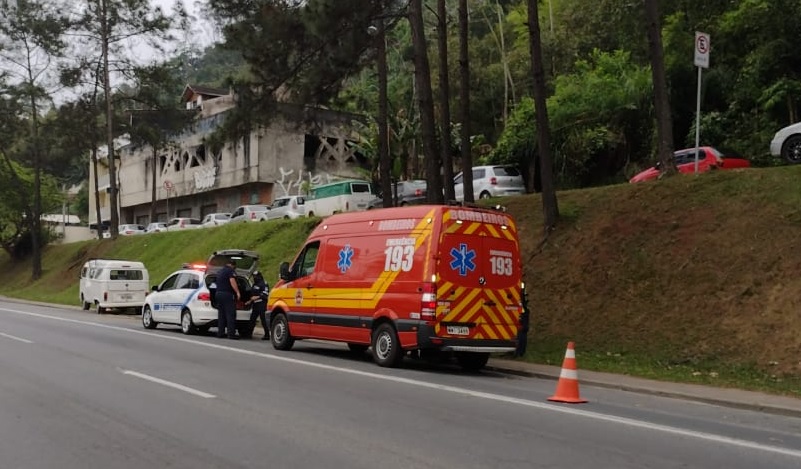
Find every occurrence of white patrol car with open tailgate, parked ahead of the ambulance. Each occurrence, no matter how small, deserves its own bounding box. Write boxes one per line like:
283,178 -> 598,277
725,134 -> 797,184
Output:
142,249 -> 259,337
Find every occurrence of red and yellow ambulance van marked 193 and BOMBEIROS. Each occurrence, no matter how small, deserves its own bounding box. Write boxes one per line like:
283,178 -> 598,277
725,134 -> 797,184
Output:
268,205 -> 522,370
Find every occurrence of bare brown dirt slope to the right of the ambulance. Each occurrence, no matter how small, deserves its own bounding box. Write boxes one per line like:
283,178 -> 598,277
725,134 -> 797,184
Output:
507,167 -> 801,376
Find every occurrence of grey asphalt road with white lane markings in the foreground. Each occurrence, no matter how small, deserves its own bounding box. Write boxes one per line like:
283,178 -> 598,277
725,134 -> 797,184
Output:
0,303 -> 801,469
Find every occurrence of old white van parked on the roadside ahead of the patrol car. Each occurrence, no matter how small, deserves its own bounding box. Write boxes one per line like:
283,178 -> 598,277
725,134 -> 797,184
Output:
80,259 -> 150,314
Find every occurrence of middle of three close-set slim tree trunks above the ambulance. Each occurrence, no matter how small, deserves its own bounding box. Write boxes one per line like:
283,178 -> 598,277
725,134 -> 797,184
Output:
437,0 -> 456,200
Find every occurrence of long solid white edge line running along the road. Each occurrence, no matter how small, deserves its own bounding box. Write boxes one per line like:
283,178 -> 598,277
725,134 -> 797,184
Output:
0,308 -> 801,459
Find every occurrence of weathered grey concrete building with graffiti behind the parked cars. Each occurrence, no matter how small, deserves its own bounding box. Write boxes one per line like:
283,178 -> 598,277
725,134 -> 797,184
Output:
89,85 -> 369,229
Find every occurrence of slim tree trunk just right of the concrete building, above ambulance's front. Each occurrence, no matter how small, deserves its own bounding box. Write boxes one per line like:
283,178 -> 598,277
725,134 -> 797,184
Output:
376,18 -> 394,207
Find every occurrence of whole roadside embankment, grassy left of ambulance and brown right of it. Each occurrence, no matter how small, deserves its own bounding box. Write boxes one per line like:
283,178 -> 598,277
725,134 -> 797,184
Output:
0,167 -> 801,396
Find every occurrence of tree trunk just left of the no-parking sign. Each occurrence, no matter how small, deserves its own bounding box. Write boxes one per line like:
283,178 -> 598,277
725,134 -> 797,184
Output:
645,0 -> 676,174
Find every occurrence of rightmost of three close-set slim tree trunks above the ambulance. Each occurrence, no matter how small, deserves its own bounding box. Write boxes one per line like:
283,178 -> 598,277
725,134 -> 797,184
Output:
459,0 -> 475,202
